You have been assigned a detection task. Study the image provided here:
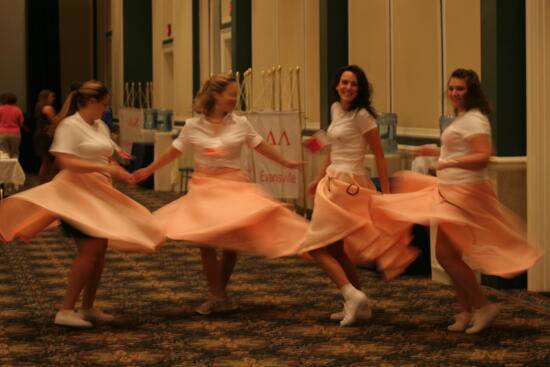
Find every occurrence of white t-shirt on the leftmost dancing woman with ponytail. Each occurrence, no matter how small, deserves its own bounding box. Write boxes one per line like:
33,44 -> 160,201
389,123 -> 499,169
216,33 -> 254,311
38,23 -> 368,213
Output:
50,112 -> 114,164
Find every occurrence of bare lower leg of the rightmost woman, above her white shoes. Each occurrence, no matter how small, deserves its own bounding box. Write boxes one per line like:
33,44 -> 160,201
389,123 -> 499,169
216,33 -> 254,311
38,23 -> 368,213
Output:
436,230 -> 489,312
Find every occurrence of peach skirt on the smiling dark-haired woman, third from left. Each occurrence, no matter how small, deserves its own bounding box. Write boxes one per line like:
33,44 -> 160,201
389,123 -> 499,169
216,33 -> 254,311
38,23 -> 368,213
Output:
300,171 -> 419,279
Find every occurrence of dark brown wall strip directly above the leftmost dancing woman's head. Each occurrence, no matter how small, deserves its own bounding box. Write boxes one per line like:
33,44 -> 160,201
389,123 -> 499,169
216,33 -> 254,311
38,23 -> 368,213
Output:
59,0 -> 94,99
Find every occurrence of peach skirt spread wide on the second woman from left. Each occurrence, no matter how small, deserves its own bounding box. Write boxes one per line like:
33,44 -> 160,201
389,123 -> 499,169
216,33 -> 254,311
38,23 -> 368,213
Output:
153,168 -> 308,258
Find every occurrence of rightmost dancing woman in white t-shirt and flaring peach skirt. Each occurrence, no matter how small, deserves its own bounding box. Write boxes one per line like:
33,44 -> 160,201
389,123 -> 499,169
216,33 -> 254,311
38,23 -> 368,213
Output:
374,69 -> 542,334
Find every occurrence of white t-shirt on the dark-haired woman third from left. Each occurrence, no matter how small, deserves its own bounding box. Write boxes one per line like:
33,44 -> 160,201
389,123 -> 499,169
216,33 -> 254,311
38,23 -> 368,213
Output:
327,102 -> 377,175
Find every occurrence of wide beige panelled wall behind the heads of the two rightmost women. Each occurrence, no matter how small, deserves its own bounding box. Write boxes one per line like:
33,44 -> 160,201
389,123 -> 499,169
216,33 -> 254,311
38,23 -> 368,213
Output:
349,0 -> 481,138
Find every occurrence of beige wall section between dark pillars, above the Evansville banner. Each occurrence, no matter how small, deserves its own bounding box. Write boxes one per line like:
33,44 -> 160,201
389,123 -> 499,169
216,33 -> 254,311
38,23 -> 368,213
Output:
252,0 -> 320,126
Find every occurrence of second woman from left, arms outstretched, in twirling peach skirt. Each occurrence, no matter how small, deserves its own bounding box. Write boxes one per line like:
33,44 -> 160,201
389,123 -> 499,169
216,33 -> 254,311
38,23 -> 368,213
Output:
134,74 -> 307,315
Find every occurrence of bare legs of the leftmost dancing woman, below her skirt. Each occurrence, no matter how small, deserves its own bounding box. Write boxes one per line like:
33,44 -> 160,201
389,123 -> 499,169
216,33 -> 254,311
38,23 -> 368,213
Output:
61,238 -> 109,310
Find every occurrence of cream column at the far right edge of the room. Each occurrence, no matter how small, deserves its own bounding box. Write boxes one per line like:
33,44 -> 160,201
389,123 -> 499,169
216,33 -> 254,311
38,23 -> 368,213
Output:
525,0 -> 550,292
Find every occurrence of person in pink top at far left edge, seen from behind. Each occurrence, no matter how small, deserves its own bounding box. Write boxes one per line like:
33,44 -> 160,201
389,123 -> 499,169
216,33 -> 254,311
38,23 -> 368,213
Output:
0,93 -> 24,158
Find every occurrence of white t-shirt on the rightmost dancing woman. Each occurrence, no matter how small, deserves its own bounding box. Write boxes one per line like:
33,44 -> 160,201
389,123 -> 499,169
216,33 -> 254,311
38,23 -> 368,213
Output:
437,109 -> 491,184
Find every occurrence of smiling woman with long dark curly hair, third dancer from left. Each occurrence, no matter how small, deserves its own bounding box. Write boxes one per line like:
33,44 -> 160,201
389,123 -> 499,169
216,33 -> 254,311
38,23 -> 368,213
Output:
300,65 -> 417,326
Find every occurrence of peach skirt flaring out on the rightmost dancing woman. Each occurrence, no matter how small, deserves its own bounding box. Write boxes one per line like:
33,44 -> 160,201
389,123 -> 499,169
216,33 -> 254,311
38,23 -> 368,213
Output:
373,172 -> 542,277
